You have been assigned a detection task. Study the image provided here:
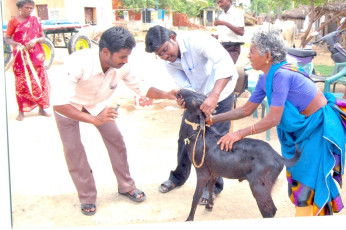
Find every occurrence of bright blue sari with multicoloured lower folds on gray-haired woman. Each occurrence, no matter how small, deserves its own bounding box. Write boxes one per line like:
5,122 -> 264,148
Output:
265,61 -> 345,215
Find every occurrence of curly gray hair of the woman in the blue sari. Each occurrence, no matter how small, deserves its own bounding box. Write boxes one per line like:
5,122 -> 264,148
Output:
251,29 -> 287,64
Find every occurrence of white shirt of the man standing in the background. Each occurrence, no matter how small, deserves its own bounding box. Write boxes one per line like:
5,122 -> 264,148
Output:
216,5 -> 245,42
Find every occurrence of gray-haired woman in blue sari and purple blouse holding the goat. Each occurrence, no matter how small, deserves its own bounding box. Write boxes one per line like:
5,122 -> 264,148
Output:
209,30 -> 345,216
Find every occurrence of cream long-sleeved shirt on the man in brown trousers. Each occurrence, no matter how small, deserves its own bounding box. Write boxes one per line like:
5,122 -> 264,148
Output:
51,47 -> 150,116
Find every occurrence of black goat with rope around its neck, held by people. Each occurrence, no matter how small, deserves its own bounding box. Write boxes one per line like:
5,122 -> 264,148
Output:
177,89 -> 301,221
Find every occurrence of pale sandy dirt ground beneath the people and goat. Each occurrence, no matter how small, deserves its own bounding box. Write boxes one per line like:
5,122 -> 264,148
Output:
6,26 -> 346,229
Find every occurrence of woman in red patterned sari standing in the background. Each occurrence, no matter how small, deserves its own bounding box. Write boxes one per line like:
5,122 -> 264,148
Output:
5,0 -> 50,121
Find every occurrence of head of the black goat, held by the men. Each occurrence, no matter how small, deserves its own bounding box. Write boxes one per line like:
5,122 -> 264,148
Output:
176,89 -> 206,129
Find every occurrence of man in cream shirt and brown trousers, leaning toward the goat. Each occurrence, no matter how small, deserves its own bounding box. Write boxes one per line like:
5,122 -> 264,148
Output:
52,27 -> 177,215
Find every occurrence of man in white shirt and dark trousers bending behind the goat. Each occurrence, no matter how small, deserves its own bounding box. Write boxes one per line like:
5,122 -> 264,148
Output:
145,26 -> 238,204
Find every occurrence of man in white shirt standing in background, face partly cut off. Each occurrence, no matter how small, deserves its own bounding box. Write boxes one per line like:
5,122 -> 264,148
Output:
213,0 -> 245,64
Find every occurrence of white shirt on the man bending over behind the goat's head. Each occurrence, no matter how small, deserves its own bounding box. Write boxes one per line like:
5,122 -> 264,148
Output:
166,31 -> 238,101
